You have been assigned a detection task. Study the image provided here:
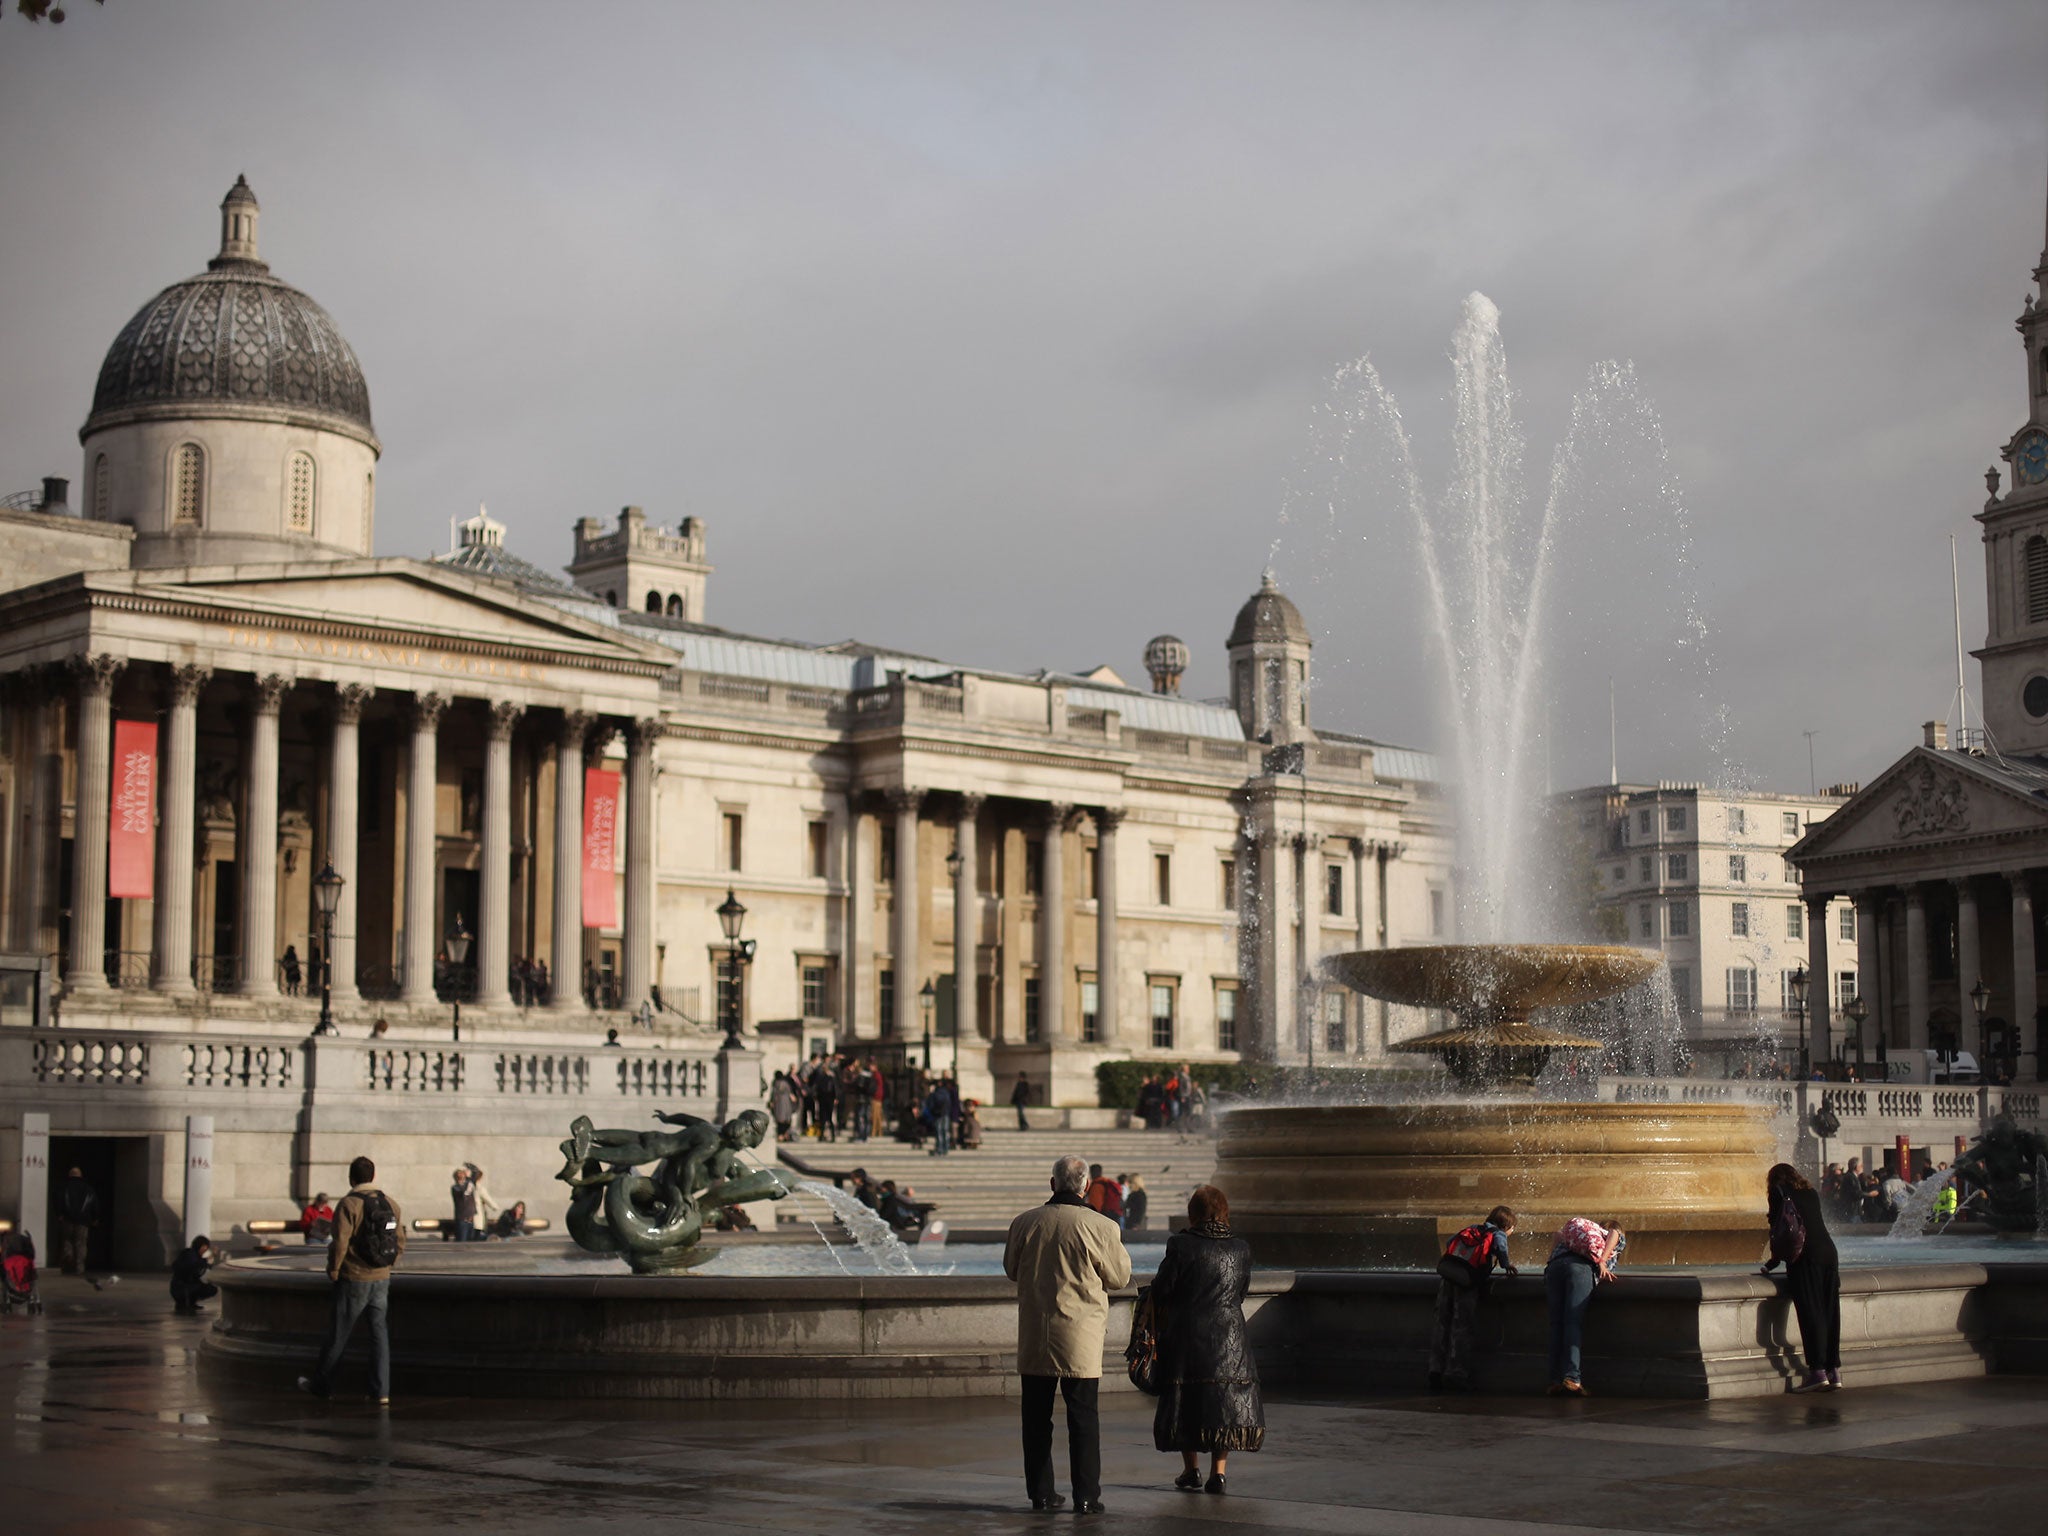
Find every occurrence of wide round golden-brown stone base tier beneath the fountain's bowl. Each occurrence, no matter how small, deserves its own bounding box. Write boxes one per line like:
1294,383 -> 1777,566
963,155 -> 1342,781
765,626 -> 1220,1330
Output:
1217,1100 -> 1776,1270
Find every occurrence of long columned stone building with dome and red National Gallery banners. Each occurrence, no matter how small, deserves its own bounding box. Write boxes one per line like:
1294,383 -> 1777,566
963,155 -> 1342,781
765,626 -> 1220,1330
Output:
0,182 -> 1454,1243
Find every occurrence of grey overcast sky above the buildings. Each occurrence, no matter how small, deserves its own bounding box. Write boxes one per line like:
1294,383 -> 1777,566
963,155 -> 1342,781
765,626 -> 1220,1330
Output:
0,0 -> 2048,806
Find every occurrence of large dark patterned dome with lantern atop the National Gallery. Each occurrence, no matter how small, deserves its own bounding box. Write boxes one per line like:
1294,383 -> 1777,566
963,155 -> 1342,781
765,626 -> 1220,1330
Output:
78,178 -> 379,453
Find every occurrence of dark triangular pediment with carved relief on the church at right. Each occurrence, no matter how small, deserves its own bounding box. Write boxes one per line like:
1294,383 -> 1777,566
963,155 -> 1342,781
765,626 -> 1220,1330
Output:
1786,748 -> 2048,868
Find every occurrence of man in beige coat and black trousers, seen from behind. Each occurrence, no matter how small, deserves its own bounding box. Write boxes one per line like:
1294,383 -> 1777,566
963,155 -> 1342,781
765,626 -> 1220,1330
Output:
1004,1157 -> 1130,1516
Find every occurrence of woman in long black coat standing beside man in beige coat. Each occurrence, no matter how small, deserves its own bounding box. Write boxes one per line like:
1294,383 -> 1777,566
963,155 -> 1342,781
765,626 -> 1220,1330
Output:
1151,1184 -> 1266,1493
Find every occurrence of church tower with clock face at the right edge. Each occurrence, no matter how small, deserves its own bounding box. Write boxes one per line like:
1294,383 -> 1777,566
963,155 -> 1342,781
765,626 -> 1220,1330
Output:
1976,174 -> 2048,756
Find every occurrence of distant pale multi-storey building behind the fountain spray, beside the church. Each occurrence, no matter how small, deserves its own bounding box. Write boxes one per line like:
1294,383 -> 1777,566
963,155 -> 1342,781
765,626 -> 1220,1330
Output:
1552,782 -> 1858,1053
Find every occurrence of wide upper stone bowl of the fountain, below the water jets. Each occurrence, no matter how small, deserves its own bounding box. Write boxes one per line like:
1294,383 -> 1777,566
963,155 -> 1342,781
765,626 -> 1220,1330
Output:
1323,944 -> 1661,1022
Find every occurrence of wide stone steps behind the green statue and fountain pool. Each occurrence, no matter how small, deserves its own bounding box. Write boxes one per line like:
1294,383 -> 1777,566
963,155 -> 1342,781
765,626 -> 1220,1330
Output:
776,1126 -> 1217,1237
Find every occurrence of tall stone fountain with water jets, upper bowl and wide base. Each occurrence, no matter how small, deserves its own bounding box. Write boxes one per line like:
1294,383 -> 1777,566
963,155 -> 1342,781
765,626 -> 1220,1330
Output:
1217,293 -> 1774,1268
